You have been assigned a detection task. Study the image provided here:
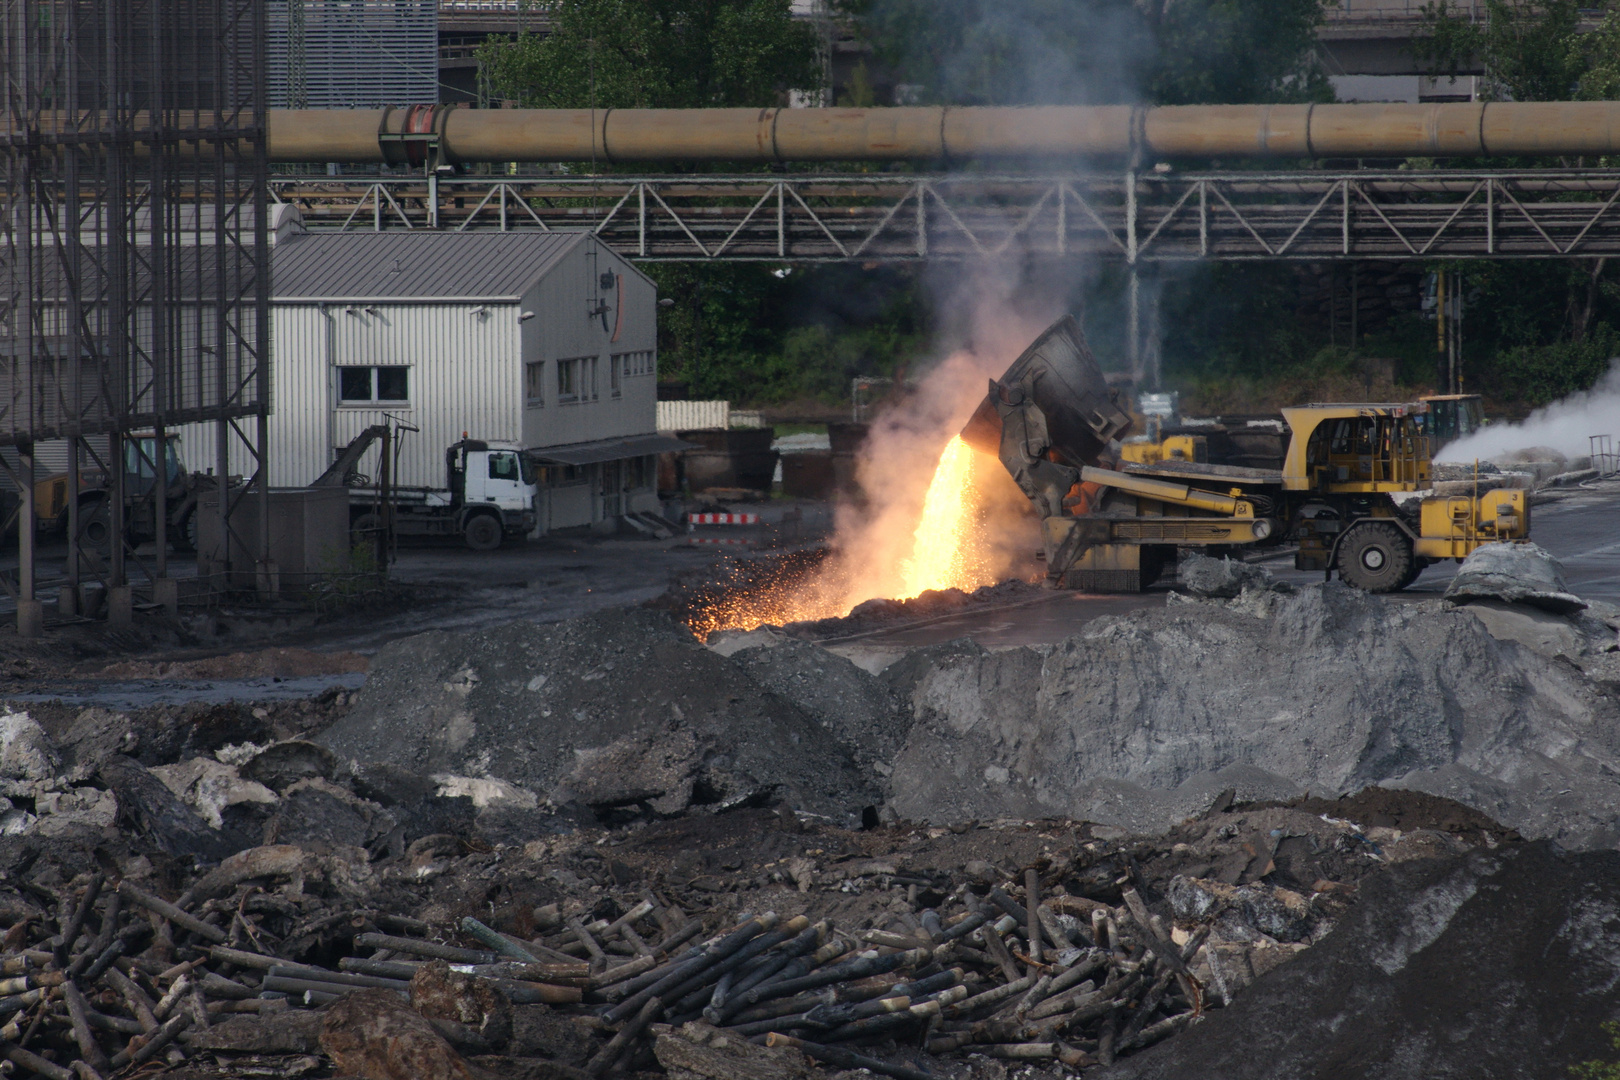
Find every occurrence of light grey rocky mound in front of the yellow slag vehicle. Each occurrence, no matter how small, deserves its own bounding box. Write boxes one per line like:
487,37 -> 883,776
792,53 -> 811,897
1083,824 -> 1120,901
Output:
885,583 -> 1620,847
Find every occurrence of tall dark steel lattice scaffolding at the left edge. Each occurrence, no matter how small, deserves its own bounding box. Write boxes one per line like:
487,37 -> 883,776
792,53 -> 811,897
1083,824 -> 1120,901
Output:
0,0 -> 272,635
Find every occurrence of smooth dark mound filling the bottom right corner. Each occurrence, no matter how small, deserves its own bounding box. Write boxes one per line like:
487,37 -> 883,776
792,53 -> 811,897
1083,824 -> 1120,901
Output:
1098,844 -> 1620,1080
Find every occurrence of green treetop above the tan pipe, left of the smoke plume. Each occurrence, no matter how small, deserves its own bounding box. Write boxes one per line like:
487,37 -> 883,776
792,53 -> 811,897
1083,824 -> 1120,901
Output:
478,0 -> 821,108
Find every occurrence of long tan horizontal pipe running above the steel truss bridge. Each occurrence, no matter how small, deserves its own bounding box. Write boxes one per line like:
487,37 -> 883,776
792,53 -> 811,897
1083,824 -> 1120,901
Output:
265,102 -> 1620,165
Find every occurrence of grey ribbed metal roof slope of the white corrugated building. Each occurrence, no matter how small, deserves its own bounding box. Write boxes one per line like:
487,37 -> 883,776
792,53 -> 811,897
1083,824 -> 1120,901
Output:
271,232 -> 588,303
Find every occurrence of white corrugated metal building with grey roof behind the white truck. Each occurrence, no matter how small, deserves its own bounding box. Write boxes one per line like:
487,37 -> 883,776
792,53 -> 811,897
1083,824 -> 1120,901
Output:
181,232 -> 679,531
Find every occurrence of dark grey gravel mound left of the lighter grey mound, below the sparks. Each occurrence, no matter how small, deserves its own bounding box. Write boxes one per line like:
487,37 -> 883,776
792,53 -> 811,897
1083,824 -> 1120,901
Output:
319,609 -> 876,821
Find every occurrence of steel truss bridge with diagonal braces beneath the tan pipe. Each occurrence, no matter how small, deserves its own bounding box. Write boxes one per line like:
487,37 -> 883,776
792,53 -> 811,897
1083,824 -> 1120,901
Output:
272,170 -> 1620,262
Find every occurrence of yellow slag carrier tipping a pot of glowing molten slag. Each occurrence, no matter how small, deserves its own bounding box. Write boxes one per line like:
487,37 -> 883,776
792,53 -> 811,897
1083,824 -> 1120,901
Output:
962,319 -> 1529,593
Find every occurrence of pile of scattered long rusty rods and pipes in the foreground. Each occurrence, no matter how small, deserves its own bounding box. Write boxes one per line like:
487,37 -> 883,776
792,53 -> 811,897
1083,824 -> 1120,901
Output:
0,845 -> 1209,1080
